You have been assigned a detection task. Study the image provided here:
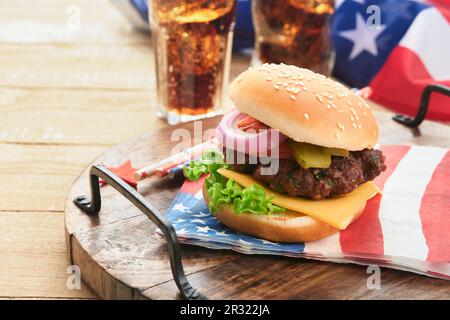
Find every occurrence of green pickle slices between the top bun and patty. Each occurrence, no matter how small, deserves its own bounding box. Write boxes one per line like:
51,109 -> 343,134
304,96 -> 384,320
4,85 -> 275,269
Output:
288,140 -> 349,169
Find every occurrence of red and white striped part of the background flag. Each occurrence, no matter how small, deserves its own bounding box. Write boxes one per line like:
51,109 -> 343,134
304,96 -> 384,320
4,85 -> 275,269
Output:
370,0 -> 450,120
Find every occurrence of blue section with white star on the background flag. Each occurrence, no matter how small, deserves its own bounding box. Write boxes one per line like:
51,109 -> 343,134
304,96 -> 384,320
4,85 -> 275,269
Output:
331,0 -> 429,88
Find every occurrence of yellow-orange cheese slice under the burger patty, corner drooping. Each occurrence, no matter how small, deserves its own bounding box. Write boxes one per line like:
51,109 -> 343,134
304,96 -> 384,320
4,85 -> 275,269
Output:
218,168 -> 381,230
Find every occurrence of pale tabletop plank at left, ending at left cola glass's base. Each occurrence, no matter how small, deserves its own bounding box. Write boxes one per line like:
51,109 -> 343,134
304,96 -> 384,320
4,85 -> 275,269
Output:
0,89 -> 166,145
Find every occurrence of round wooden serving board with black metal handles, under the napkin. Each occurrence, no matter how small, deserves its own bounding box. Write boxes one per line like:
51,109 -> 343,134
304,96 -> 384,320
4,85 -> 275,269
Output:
65,113 -> 450,299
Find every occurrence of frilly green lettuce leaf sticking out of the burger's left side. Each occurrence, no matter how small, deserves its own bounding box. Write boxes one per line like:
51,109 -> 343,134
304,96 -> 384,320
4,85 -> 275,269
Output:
183,151 -> 286,214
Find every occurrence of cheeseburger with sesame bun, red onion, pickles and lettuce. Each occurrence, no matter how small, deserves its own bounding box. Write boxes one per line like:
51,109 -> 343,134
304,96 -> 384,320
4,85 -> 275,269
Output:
184,64 -> 386,242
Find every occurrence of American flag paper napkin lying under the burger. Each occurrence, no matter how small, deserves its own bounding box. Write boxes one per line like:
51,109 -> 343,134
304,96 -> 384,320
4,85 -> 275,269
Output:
162,145 -> 450,280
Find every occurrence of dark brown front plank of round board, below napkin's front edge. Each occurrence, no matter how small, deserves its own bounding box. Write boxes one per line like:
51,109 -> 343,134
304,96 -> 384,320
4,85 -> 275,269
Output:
142,256 -> 450,300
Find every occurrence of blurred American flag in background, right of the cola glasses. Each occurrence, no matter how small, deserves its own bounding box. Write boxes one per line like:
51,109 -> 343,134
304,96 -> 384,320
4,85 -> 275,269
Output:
332,0 -> 450,121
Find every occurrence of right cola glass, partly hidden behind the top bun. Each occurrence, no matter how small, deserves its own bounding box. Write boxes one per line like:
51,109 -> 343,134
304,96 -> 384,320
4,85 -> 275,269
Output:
252,0 -> 334,75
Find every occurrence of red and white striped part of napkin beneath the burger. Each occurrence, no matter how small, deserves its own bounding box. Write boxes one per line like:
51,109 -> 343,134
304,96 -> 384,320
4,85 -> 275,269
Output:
304,145 -> 450,278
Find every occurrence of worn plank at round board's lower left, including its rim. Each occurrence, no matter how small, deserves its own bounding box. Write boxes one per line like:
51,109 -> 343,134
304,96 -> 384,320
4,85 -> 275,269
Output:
69,215 -> 239,299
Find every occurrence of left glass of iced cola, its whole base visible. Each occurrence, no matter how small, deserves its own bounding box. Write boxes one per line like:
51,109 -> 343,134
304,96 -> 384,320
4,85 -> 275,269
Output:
149,0 -> 236,124
